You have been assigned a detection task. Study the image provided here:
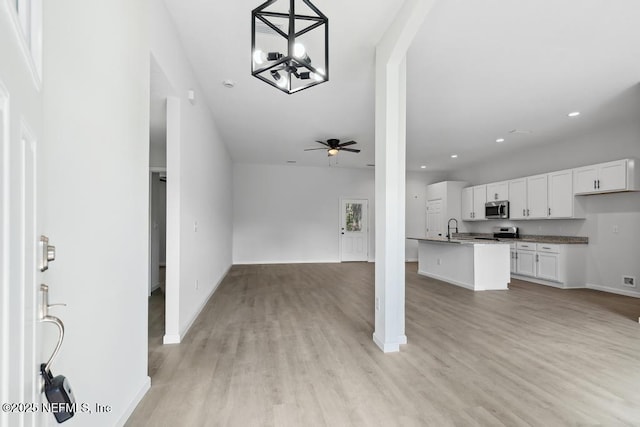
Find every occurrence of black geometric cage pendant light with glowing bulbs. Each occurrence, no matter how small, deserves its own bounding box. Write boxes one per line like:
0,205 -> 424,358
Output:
251,0 -> 329,94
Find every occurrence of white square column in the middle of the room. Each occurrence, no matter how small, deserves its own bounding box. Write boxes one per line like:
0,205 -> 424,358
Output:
373,0 -> 434,353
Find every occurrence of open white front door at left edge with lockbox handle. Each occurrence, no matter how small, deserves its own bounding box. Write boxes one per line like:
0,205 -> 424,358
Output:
0,1 -> 48,426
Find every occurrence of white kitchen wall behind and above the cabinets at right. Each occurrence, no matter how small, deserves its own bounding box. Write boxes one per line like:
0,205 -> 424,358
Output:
455,118 -> 640,296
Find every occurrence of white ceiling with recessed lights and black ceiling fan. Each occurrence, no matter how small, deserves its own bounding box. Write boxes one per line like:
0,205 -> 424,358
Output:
159,0 -> 640,171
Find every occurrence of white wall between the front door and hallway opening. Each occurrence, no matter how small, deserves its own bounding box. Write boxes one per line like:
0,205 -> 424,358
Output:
39,0 -> 149,426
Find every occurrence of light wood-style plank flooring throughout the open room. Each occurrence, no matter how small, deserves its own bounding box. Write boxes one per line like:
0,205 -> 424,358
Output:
127,263 -> 640,427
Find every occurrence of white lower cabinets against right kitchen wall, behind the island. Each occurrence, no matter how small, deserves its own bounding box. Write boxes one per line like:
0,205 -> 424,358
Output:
512,242 -> 586,288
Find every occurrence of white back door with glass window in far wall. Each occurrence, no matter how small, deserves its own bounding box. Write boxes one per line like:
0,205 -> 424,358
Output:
340,199 -> 369,262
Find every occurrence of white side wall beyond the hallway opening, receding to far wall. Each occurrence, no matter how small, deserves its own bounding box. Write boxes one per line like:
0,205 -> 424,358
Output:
151,0 -> 232,342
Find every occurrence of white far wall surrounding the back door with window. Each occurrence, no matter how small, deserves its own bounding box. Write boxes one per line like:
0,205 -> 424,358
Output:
233,164 -> 375,264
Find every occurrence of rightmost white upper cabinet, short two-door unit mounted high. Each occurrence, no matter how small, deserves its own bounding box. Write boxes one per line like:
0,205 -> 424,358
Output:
573,159 -> 640,194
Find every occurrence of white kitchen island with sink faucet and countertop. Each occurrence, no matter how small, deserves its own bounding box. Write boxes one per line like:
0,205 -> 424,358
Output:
409,237 -> 511,291
